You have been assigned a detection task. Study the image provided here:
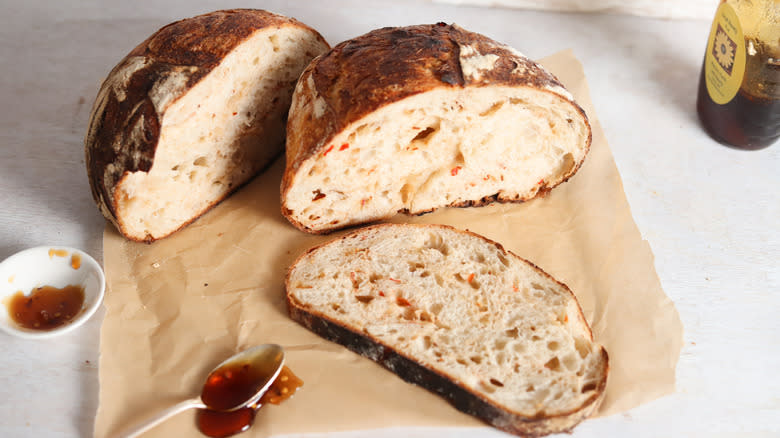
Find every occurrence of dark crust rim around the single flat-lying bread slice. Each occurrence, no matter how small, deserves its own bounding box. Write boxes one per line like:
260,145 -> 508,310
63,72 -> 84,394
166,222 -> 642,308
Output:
285,224 -> 609,437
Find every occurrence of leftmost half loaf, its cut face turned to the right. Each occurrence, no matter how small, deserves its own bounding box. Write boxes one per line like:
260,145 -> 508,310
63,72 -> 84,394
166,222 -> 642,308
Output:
85,9 -> 329,242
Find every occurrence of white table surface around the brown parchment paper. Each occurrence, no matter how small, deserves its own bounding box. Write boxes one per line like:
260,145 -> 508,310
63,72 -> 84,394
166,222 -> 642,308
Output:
0,0 -> 780,438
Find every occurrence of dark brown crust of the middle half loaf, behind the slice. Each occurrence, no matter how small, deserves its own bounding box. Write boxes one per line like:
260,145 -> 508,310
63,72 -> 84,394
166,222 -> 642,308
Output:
281,23 -> 592,234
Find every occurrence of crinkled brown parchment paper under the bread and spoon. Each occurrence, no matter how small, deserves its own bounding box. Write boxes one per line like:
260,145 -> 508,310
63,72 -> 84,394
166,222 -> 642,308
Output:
95,51 -> 682,438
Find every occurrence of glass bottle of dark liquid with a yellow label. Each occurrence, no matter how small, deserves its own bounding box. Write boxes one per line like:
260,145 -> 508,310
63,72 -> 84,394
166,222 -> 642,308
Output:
696,0 -> 780,149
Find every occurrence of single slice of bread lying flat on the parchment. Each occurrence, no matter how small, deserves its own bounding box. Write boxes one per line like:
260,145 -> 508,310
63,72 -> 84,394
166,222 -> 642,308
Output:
285,224 -> 608,436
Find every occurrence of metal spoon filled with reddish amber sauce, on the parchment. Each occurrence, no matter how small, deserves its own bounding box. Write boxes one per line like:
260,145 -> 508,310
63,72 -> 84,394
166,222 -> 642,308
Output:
119,344 -> 284,438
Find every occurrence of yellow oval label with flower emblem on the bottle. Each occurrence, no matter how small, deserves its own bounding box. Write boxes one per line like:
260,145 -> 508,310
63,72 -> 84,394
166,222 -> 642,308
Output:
704,3 -> 745,105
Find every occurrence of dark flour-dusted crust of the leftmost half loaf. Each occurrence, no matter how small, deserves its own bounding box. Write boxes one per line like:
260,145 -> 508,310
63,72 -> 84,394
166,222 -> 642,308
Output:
84,9 -> 327,243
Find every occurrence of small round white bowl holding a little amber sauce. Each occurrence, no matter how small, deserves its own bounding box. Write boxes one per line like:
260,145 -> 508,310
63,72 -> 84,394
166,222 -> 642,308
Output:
0,246 -> 106,339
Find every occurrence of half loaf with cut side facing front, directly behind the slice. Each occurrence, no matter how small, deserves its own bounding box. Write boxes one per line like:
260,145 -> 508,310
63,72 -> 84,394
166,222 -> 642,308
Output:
281,23 -> 591,233
